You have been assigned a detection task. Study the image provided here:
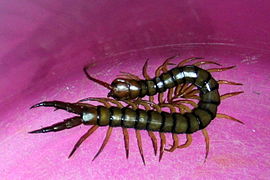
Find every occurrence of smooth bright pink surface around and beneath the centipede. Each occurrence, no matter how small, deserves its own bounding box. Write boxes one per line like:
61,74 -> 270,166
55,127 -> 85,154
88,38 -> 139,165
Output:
0,0 -> 270,179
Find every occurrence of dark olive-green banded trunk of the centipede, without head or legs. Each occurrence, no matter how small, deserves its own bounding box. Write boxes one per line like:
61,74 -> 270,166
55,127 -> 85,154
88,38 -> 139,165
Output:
82,66 -> 220,134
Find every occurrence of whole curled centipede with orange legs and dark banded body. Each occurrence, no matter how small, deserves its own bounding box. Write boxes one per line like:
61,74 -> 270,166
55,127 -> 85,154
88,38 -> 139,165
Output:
29,57 -> 243,164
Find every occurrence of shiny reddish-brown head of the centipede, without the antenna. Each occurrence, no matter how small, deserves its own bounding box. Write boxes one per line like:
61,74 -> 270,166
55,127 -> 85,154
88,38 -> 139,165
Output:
108,78 -> 140,100
